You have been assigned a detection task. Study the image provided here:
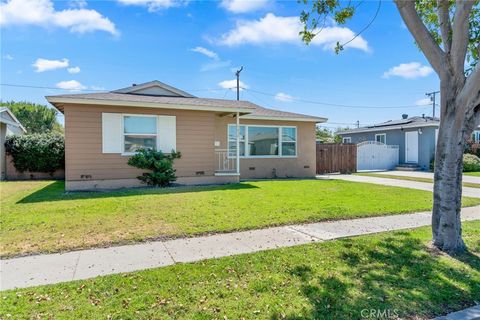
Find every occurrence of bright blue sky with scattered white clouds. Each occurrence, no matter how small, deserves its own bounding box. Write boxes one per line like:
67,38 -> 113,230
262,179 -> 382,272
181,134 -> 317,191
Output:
0,0 -> 438,128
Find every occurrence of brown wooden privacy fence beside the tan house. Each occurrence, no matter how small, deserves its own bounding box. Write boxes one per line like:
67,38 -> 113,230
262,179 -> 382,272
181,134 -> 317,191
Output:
317,143 -> 357,174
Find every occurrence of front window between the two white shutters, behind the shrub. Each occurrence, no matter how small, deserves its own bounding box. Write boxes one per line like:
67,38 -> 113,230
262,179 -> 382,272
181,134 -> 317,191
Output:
123,116 -> 157,153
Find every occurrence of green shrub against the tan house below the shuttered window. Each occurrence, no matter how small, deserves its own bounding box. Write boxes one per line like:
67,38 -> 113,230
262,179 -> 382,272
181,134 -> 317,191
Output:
128,149 -> 181,187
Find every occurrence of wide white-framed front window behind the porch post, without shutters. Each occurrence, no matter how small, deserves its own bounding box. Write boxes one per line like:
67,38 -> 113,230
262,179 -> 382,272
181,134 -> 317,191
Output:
228,124 -> 297,158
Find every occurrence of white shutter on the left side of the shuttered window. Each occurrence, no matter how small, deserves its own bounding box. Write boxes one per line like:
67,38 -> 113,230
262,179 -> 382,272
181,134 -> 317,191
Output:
102,113 -> 123,153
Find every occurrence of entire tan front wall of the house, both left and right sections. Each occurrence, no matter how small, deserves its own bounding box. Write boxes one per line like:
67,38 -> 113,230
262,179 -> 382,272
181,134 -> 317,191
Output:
64,105 -> 315,190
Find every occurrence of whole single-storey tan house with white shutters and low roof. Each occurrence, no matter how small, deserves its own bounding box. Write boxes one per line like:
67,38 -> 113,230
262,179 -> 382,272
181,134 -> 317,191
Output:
46,81 -> 326,190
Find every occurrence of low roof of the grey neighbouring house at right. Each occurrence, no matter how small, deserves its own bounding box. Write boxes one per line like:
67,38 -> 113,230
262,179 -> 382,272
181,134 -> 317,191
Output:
338,117 -> 440,135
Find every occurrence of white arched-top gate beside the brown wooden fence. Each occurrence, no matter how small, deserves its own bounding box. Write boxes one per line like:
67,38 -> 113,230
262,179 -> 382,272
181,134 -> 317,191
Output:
357,141 -> 399,171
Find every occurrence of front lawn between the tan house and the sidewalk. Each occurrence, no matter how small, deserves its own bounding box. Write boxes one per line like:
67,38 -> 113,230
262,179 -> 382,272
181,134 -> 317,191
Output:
0,180 -> 480,256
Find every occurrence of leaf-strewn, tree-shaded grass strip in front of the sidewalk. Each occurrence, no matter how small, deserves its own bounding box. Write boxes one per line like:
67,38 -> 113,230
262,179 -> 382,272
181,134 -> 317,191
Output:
0,221 -> 480,320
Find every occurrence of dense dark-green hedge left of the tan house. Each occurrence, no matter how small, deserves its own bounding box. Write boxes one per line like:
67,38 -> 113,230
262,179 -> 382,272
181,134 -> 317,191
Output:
5,133 -> 65,174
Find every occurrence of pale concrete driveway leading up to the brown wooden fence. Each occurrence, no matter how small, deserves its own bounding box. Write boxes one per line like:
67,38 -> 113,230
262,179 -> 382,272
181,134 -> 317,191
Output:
326,174 -> 480,198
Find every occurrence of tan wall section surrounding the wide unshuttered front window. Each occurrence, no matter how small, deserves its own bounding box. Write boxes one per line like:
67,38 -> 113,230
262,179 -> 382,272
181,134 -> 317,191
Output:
215,116 -> 316,179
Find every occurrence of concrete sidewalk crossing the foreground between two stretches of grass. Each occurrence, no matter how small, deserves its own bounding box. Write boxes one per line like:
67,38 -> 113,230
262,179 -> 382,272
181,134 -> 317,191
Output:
0,206 -> 480,290
